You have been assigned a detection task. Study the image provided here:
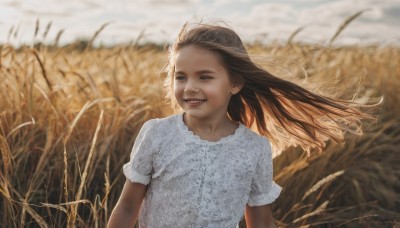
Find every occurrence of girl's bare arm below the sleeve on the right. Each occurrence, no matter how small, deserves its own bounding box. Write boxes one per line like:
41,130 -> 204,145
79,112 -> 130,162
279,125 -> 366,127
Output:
245,205 -> 275,228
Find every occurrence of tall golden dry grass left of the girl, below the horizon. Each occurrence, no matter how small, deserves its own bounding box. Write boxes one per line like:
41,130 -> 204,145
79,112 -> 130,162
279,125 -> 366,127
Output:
0,43 -> 169,227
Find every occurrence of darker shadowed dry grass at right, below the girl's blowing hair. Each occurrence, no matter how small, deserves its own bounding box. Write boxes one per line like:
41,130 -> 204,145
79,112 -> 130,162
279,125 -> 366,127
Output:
275,116 -> 400,227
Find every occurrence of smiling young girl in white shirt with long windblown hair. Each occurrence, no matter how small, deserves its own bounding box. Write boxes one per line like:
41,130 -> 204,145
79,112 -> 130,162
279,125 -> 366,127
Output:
108,24 -> 370,228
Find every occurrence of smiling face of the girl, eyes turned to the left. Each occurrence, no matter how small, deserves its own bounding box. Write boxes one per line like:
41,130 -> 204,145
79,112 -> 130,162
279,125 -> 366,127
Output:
174,45 -> 240,120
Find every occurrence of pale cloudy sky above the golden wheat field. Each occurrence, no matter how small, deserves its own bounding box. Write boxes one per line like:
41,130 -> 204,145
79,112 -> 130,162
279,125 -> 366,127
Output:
0,0 -> 400,45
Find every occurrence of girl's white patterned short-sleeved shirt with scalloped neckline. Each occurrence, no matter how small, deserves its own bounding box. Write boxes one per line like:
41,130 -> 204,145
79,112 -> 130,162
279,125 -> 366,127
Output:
123,114 -> 281,228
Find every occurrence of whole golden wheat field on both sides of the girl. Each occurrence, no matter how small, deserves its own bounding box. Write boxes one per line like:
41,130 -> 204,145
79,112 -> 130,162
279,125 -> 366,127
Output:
0,24 -> 400,227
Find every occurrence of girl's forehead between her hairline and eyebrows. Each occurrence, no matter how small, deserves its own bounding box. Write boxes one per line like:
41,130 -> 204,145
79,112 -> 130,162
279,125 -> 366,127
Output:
175,45 -> 225,71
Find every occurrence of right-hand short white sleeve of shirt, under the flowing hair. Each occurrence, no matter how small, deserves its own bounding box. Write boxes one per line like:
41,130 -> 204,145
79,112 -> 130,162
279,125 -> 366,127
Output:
247,138 -> 281,206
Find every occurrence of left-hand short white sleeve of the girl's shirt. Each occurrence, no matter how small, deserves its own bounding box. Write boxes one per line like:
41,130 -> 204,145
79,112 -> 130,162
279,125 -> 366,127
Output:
123,119 -> 157,185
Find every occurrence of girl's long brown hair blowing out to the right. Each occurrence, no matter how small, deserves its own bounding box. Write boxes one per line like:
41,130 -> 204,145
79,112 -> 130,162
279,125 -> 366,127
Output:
164,23 -> 373,153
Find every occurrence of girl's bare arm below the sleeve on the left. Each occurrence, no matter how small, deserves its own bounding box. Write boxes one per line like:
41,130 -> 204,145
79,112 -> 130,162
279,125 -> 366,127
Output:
107,179 -> 147,228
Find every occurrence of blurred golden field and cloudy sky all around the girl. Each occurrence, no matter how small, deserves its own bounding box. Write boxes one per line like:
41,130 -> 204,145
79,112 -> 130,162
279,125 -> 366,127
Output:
0,0 -> 400,227
